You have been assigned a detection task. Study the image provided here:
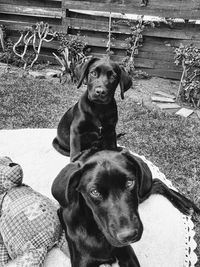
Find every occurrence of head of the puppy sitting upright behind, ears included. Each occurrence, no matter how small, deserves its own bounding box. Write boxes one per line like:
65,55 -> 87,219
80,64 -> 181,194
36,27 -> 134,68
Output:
78,58 -> 132,104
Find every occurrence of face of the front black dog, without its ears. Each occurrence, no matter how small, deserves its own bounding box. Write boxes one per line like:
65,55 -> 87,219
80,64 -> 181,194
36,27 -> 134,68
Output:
77,155 -> 143,247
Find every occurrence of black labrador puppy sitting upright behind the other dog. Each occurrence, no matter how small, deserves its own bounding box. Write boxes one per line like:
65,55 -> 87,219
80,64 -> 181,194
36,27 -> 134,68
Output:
53,58 -> 132,159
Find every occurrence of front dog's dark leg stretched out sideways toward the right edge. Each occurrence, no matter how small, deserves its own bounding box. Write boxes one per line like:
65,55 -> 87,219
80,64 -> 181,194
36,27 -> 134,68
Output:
151,179 -> 200,215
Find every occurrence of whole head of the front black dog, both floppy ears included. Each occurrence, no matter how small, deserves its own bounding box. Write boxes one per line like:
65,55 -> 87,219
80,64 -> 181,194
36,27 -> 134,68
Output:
53,150 -> 152,247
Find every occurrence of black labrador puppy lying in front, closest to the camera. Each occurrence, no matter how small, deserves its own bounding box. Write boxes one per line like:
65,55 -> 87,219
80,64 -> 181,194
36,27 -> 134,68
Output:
52,148 -> 200,267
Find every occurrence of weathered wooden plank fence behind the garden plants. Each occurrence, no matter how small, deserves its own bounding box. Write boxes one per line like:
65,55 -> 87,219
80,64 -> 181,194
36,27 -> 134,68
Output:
0,0 -> 200,79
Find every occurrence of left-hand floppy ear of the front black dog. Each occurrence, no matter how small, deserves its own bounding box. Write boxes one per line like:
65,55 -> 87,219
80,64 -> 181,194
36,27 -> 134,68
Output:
51,162 -> 81,207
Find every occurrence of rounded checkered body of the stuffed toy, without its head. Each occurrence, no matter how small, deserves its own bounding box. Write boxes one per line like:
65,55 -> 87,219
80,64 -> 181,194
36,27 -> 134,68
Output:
0,186 -> 62,266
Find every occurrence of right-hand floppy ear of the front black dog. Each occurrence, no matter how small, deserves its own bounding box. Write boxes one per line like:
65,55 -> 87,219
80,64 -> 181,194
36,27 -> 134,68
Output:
121,149 -> 152,201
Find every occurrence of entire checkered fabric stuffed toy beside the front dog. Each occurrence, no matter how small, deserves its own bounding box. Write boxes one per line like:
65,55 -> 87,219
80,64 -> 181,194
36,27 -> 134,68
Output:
0,158 -> 63,267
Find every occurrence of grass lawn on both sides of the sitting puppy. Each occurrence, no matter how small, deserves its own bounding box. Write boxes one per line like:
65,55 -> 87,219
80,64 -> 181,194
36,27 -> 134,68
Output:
0,71 -> 200,267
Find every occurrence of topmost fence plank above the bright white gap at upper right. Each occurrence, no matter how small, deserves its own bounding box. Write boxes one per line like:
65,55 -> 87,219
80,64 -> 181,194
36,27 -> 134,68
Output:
63,0 -> 200,19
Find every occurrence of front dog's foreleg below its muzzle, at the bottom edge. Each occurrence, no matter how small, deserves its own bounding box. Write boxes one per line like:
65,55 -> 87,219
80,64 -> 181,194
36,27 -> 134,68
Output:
114,246 -> 140,267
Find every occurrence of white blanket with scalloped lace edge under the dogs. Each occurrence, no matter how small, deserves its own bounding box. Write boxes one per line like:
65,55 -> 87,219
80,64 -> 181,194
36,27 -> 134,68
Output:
0,129 -> 197,267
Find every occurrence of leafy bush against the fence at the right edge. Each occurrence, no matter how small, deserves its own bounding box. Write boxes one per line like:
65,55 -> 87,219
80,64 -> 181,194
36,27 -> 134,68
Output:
175,44 -> 200,108
